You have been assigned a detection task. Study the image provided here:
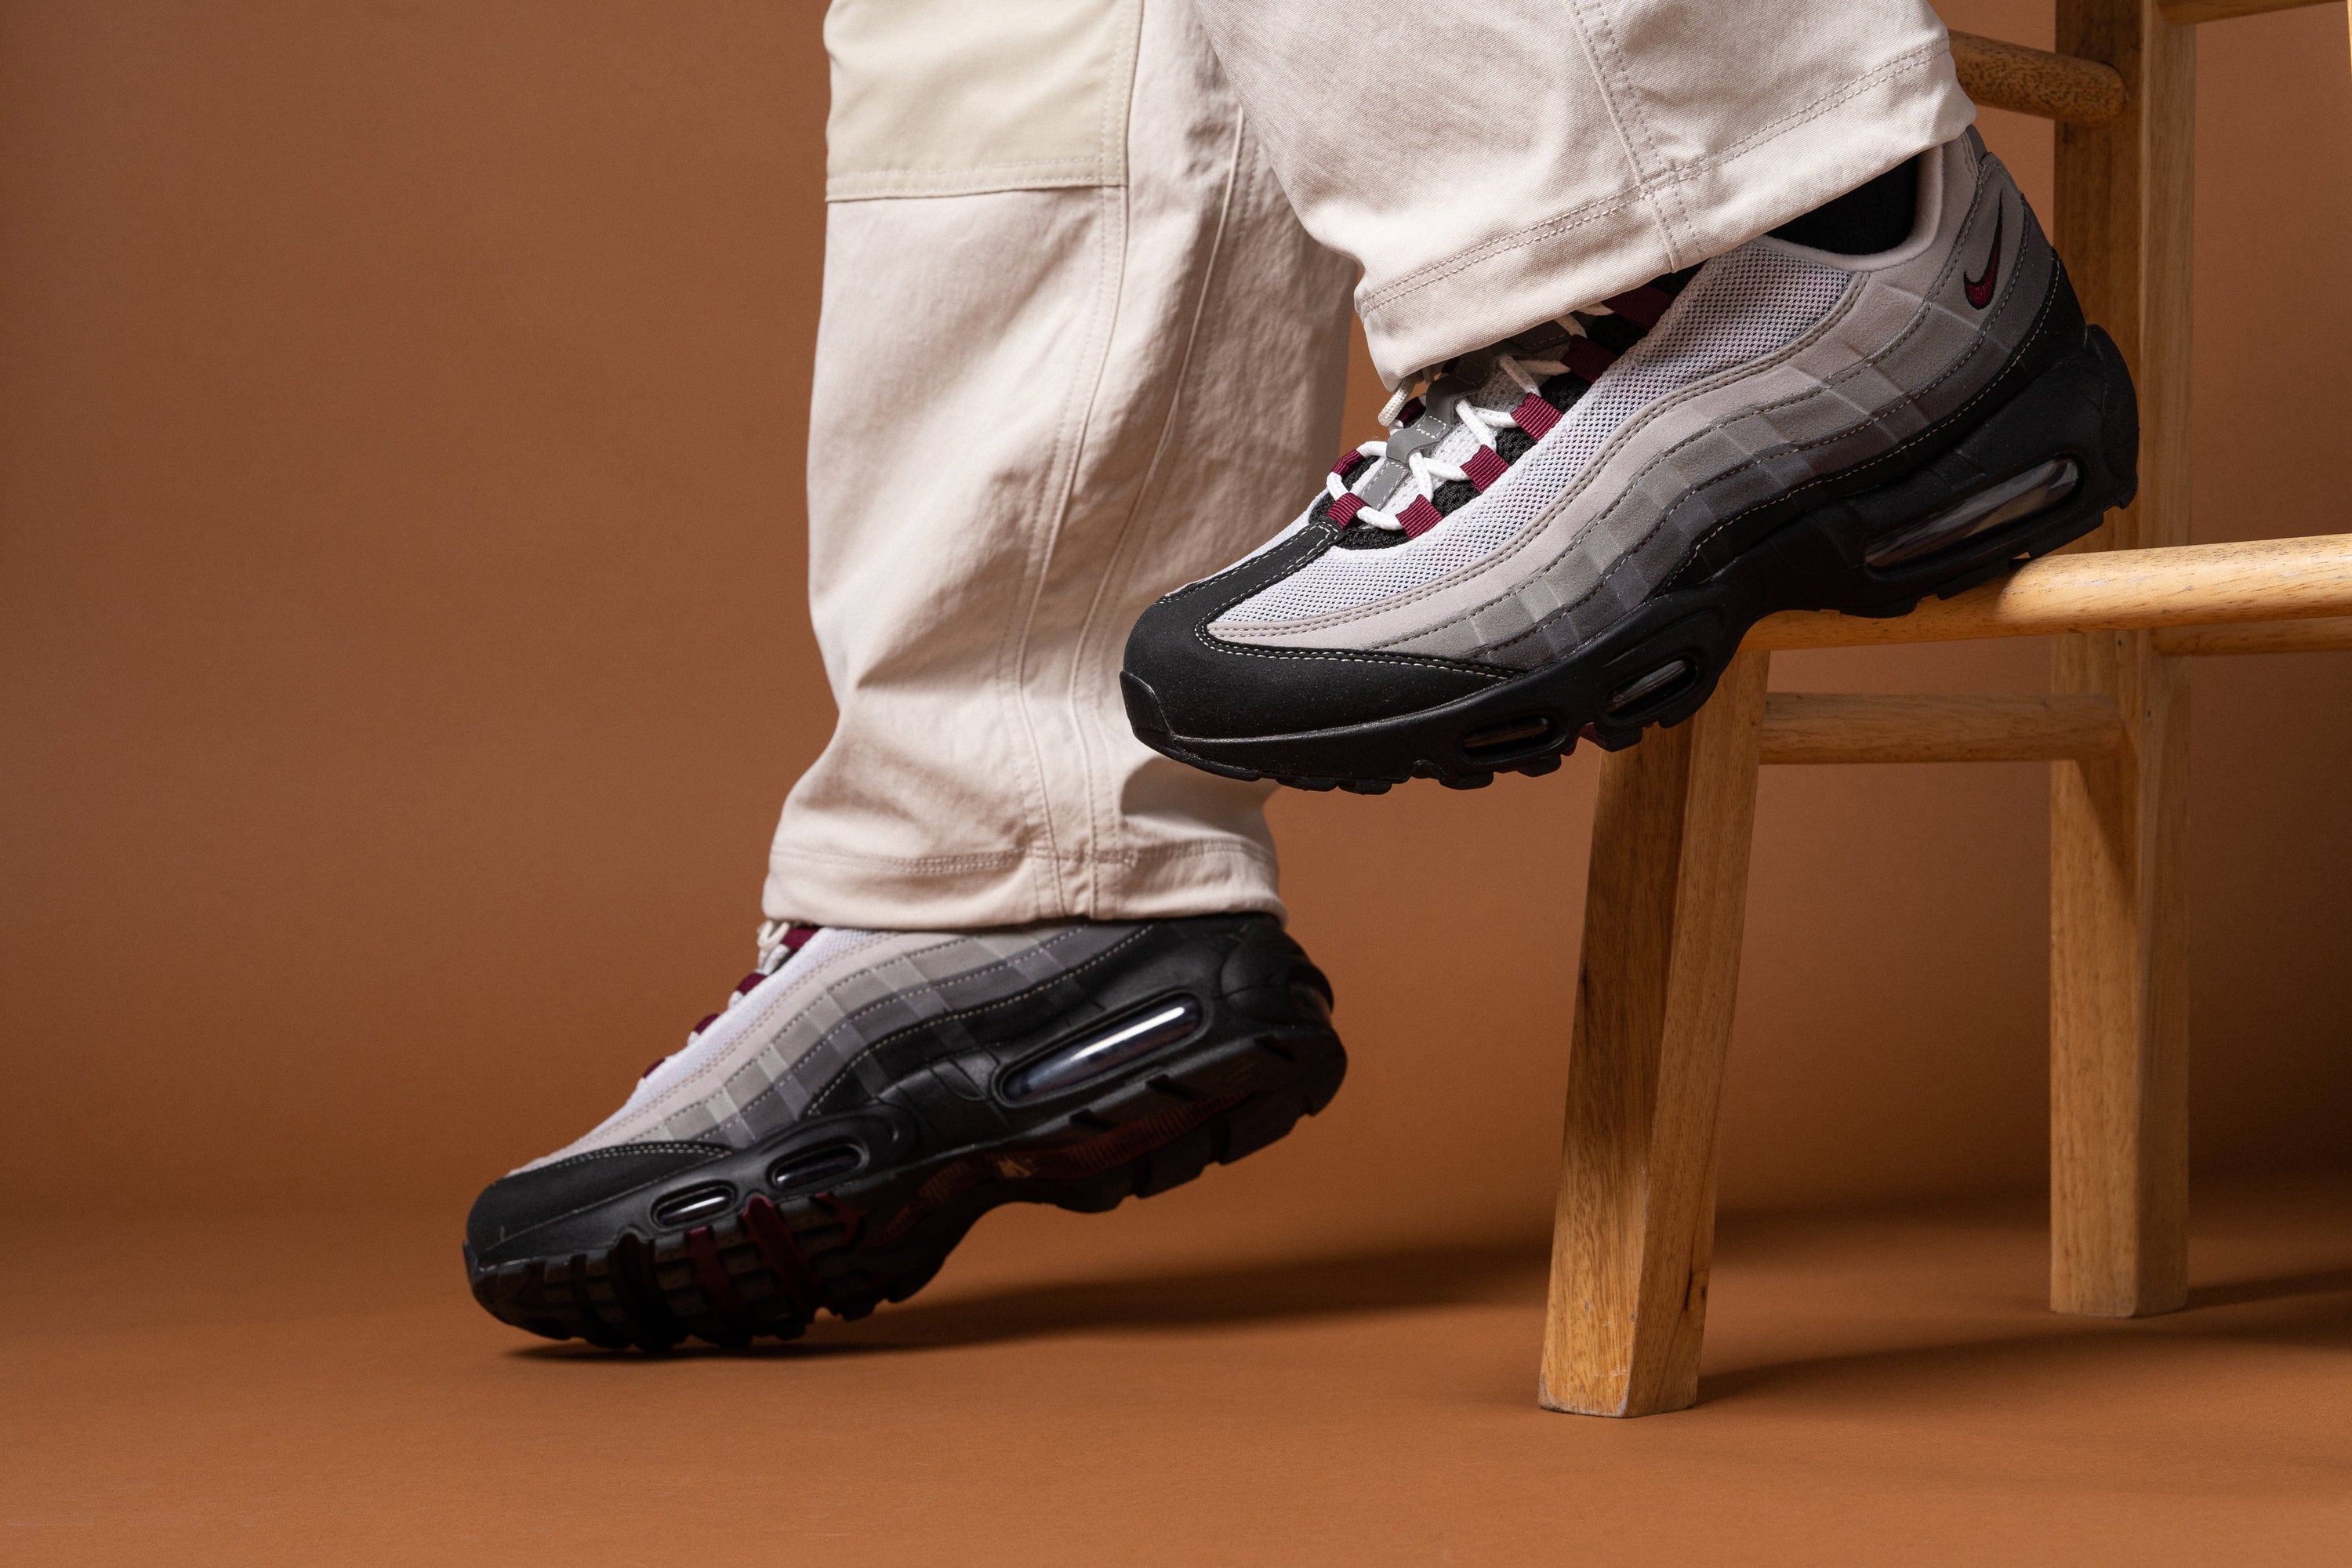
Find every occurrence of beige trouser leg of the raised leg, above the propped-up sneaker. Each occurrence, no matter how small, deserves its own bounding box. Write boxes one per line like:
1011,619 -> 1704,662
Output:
1195,0 -> 1976,386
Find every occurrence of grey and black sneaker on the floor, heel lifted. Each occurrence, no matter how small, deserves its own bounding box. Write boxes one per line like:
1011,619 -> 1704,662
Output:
466,914 -> 1348,1349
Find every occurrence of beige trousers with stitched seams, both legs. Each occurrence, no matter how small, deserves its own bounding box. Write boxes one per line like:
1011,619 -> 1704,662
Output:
764,0 -> 1973,928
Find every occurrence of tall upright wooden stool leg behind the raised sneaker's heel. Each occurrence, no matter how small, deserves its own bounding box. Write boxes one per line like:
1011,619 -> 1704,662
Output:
2051,0 -> 2197,1316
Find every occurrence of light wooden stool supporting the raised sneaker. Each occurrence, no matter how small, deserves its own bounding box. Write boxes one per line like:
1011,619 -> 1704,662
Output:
1538,0 -> 2352,1415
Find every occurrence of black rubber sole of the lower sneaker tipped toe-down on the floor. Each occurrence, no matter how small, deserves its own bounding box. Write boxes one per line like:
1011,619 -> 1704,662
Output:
466,1029 -> 1348,1352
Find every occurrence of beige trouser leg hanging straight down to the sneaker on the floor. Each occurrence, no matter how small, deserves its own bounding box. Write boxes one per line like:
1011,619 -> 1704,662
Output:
764,0 -> 1348,928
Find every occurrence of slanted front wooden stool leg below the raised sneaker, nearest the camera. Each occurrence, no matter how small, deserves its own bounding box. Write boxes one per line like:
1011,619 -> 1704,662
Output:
1536,654 -> 1771,1415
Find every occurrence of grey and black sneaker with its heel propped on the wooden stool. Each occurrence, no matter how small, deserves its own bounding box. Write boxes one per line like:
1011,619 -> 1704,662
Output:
1122,132 -> 2138,792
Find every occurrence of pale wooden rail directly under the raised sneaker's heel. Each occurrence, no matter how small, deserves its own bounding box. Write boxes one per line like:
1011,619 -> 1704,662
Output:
1740,534 -> 2352,652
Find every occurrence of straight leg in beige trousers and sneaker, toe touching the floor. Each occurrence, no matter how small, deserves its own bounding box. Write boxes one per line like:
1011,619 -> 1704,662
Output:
466,0 -> 1348,1347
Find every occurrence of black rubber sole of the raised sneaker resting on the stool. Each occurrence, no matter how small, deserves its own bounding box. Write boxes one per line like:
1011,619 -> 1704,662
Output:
1122,327 -> 2138,794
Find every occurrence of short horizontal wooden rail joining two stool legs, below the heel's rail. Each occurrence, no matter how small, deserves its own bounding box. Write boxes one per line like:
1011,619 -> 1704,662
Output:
1762,691 -> 2124,762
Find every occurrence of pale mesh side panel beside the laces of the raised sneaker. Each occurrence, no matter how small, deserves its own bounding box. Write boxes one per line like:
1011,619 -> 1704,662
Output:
1223,247 -> 1853,626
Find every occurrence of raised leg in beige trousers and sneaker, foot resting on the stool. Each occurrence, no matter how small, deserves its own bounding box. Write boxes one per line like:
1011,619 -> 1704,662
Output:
1122,0 -> 2138,792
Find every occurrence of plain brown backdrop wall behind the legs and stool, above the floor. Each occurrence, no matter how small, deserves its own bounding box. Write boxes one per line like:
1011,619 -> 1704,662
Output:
0,0 -> 2352,1253
